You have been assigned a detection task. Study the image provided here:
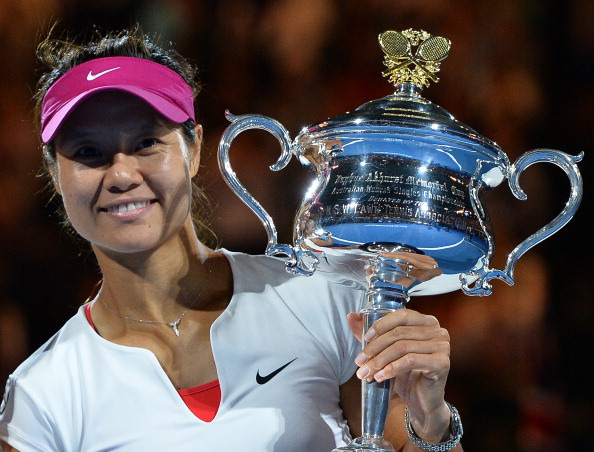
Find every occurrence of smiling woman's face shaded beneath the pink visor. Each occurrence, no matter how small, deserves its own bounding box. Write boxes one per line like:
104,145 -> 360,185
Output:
53,91 -> 200,253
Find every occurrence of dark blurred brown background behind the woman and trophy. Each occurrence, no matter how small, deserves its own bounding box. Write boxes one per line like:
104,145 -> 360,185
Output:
0,0 -> 594,452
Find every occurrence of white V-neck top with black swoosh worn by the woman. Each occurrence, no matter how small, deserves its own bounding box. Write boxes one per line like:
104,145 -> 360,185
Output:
0,251 -> 364,452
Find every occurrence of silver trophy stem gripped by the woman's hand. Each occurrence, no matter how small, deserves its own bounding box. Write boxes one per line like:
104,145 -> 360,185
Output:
333,245 -> 416,452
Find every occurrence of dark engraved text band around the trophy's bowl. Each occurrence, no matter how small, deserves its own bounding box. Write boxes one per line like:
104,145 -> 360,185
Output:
319,155 -> 484,238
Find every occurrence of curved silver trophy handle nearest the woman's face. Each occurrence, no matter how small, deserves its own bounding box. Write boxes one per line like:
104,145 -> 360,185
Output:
218,111 -> 318,276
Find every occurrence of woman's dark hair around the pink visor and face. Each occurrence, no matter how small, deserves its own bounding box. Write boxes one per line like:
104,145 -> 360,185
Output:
34,25 -> 217,246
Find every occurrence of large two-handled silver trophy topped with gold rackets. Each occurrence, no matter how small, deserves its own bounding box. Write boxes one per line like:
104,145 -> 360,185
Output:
219,30 -> 582,451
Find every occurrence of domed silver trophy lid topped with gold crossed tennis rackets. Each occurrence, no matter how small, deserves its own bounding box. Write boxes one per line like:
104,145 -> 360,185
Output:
298,29 -> 505,160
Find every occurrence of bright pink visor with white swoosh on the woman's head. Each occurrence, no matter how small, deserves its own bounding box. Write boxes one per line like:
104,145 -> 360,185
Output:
41,57 -> 196,143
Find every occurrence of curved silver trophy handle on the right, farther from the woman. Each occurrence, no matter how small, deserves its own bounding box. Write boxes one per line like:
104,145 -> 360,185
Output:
462,149 -> 584,296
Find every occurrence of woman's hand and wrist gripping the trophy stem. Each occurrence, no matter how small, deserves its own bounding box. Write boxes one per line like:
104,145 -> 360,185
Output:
348,309 -> 450,442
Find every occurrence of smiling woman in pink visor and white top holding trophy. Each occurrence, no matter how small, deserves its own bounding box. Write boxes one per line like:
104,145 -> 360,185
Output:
0,29 -> 461,452
